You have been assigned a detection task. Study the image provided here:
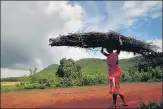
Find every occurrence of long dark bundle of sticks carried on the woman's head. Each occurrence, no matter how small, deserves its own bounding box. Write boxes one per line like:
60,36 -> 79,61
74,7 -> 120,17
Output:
49,31 -> 160,55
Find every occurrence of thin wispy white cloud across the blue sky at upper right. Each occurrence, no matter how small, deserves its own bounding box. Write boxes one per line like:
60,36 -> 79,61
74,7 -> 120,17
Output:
81,1 -> 162,31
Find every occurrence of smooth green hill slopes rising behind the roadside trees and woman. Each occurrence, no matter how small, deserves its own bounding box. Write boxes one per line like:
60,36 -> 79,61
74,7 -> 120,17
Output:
38,58 -> 134,75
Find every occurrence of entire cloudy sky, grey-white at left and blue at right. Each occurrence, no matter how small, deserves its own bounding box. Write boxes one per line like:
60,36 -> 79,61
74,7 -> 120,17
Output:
1,1 -> 162,77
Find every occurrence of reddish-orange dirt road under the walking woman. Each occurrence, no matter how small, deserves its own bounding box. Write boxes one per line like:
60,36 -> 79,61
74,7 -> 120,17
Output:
1,83 -> 162,108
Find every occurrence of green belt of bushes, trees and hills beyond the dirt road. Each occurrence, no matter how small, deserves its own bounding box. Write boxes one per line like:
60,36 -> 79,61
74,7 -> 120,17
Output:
1,57 -> 163,92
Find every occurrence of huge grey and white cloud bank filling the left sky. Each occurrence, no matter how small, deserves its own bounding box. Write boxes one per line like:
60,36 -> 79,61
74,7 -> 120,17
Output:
1,1 -> 86,76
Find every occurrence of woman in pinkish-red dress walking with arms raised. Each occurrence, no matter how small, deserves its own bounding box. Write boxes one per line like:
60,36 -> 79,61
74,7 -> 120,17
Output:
101,37 -> 128,107
